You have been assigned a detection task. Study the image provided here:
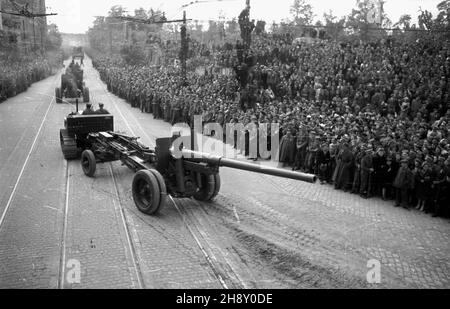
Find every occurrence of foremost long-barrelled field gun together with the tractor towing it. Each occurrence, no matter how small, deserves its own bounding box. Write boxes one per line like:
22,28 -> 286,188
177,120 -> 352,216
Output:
60,114 -> 316,215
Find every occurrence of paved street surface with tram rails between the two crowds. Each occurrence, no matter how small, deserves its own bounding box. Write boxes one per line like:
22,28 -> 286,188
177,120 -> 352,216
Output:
0,60 -> 450,289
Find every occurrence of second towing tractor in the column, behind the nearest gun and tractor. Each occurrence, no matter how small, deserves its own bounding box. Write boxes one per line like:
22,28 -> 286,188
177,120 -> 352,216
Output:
55,61 -> 90,103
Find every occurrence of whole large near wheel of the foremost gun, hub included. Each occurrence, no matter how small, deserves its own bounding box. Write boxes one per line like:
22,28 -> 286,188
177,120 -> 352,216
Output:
132,170 -> 166,215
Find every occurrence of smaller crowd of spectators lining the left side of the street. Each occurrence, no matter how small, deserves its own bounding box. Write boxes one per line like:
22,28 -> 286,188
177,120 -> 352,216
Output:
0,55 -> 62,103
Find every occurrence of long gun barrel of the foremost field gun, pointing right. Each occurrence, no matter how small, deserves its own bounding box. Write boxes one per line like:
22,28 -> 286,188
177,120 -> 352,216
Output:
181,149 -> 317,183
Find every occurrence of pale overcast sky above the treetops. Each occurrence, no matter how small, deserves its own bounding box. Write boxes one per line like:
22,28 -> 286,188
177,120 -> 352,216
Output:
46,0 -> 441,33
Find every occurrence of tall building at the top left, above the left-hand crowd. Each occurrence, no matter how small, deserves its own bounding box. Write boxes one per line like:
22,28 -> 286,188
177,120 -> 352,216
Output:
0,0 -> 47,51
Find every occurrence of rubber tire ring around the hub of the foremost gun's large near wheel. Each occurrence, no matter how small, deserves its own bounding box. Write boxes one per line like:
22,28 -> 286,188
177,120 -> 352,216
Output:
132,170 -> 161,215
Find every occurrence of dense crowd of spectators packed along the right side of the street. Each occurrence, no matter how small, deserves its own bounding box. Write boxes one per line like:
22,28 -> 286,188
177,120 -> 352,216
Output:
89,35 -> 450,216
